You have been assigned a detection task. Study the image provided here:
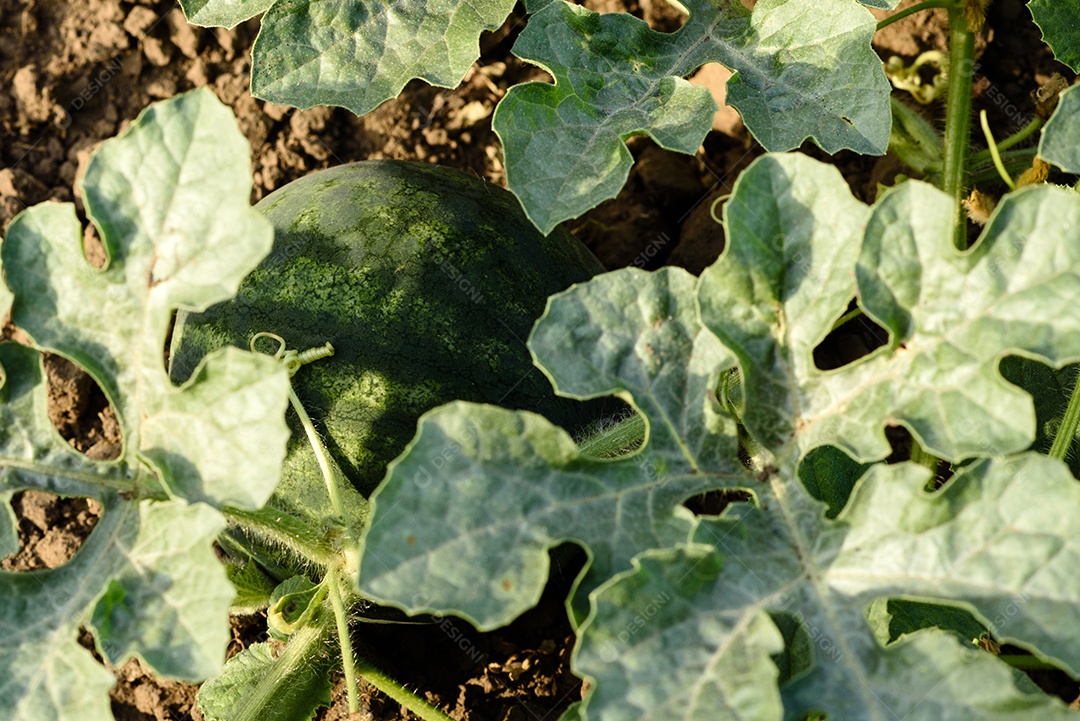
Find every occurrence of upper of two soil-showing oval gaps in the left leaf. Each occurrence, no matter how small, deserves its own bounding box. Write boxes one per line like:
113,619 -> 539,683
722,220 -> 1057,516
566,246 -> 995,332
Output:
44,353 -> 123,461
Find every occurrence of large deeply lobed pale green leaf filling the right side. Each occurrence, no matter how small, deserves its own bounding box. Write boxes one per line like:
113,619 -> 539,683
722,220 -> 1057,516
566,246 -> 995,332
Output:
361,154 -> 1080,719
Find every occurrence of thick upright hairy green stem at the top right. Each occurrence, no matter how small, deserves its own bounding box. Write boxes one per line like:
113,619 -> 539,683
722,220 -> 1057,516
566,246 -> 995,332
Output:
942,3 -> 975,248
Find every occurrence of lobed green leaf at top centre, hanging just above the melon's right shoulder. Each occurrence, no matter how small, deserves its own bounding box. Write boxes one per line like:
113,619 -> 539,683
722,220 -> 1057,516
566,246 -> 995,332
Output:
492,0 -> 891,233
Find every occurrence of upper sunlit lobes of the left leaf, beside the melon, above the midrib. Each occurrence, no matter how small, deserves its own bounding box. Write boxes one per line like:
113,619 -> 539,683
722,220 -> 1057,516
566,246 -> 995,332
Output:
2,85 -> 287,508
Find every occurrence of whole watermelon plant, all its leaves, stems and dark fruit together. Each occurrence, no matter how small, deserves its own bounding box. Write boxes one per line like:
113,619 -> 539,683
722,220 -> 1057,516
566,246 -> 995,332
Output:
0,0 -> 1080,721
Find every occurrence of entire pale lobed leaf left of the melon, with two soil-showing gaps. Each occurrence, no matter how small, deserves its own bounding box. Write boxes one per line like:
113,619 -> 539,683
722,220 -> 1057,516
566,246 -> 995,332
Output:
0,91 -> 288,721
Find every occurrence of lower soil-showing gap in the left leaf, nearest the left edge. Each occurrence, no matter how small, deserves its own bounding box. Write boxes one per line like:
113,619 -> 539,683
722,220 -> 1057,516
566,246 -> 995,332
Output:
0,490 -> 102,571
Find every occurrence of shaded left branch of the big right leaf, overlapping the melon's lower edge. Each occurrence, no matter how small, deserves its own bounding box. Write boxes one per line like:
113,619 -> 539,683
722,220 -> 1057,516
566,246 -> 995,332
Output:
360,268 -> 745,628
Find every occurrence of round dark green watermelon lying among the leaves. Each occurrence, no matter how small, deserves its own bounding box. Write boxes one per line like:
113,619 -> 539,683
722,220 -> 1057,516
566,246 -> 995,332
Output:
171,161 -> 603,505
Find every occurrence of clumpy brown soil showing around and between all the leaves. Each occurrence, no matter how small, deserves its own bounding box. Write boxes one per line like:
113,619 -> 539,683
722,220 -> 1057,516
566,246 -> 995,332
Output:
0,0 -> 1075,721
